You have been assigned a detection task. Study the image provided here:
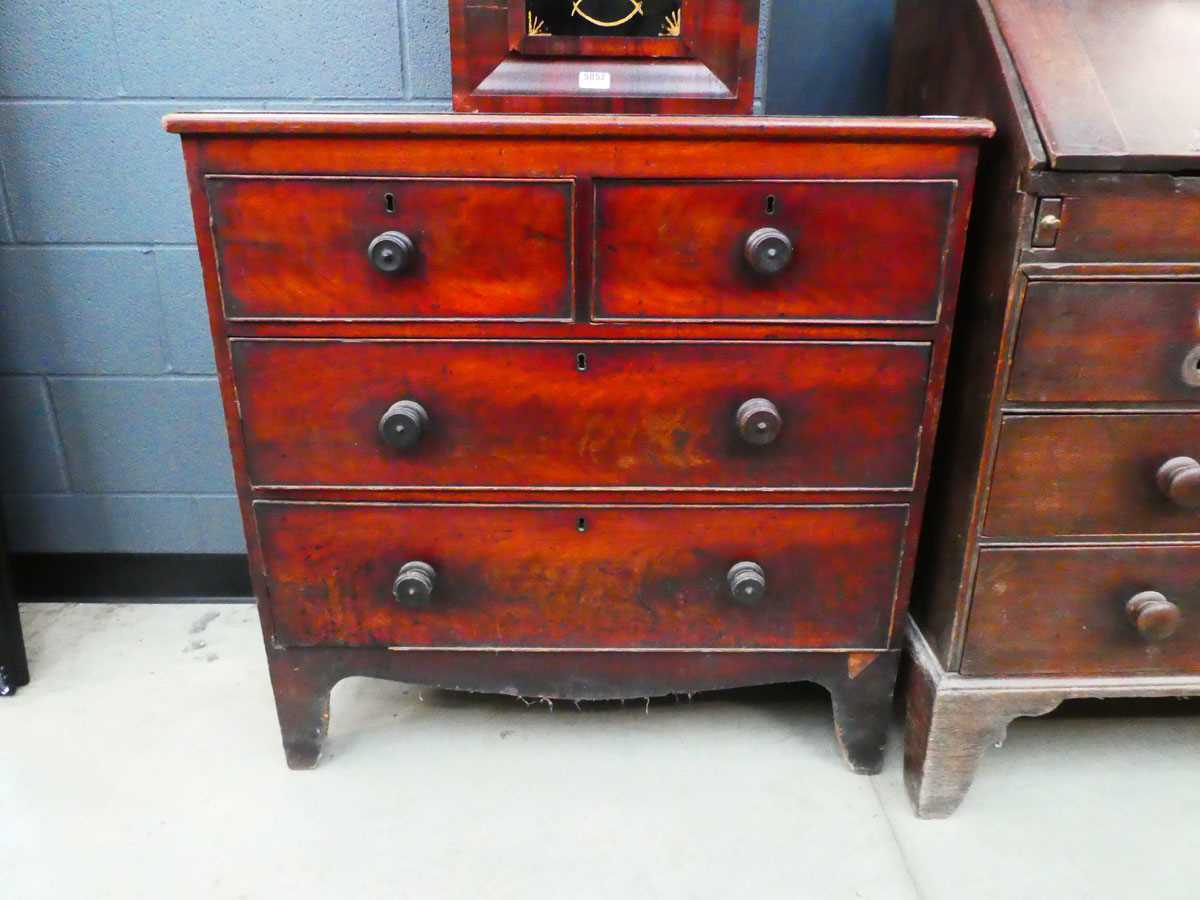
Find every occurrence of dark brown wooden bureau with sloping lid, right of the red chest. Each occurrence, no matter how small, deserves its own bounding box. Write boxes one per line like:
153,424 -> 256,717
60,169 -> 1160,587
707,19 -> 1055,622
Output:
893,0 -> 1200,816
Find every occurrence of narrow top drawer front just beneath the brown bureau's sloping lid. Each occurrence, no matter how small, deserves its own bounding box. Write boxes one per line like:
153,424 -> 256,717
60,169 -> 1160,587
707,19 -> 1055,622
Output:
1030,175 -> 1200,263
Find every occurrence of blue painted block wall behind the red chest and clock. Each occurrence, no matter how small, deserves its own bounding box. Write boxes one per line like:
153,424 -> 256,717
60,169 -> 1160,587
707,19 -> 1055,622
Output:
0,0 -> 890,553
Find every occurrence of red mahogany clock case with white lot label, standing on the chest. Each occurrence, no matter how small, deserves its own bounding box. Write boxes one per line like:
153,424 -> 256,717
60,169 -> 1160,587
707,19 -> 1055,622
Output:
450,0 -> 760,114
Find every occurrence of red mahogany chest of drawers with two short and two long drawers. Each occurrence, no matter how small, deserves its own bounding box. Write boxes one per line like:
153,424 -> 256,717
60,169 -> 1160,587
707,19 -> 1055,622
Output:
167,114 -> 991,772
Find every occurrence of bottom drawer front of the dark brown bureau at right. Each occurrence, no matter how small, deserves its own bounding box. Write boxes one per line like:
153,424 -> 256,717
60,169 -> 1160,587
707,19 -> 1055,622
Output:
962,545 -> 1200,676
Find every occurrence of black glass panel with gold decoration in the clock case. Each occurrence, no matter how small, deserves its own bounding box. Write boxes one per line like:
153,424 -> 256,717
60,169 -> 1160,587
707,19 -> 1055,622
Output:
524,0 -> 684,37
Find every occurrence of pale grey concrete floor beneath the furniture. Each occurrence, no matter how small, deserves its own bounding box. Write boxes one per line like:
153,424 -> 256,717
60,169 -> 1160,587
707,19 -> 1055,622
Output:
0,604 -> 1200,900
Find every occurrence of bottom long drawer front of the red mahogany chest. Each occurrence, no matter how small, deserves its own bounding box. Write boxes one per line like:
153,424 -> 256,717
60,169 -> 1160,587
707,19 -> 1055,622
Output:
254,502 -> 907,649
